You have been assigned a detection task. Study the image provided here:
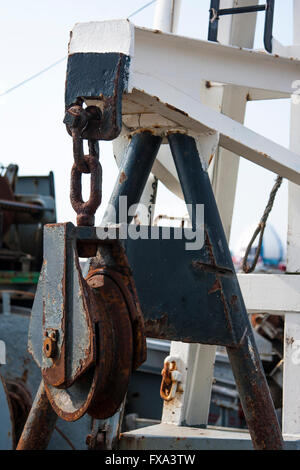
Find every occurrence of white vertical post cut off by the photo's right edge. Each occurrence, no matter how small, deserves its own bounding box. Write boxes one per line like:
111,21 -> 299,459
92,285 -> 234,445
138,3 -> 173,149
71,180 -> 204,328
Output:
282,0 -> 300,434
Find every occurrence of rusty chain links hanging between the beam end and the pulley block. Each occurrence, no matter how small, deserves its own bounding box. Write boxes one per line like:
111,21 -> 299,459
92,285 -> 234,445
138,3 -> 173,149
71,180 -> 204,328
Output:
65,103 -> 102,226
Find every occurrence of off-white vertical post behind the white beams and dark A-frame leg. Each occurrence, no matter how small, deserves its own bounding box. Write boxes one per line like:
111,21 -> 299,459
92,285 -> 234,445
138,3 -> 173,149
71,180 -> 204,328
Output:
162,0 -> 258,426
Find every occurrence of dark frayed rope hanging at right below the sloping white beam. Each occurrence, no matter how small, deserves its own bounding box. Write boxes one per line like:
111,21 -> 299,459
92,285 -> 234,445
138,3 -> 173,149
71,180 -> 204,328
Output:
243,176 -> 282,273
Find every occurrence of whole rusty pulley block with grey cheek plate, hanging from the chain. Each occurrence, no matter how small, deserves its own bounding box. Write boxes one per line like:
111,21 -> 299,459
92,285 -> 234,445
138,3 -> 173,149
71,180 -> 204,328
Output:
29,223 -> 146,421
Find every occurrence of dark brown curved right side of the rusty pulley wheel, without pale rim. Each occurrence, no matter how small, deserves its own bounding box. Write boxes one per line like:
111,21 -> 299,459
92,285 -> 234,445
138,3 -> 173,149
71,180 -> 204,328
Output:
82,270 -> 133,419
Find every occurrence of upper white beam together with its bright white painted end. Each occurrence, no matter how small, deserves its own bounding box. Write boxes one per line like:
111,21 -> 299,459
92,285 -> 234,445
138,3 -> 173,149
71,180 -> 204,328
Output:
69,20 -> 300,96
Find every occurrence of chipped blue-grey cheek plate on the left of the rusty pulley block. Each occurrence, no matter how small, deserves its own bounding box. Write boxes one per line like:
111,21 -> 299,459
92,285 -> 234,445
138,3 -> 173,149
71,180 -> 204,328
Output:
29,224 -> 96,386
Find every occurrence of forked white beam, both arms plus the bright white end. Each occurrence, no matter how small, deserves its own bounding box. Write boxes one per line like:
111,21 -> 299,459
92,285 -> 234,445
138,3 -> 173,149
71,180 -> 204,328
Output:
70,20 -> 300,184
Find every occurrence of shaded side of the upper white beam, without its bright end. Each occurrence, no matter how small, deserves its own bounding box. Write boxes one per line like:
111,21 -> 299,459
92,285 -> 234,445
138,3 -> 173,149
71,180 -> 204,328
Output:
133,28 -> 300,96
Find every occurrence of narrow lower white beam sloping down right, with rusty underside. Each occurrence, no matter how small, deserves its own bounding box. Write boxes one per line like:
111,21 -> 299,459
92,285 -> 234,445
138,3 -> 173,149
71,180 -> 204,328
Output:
127,88 -> 300,184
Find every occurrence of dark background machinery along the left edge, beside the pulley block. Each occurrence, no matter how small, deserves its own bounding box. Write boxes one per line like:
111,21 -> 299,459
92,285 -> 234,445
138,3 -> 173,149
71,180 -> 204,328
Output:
0,164 -> 56,447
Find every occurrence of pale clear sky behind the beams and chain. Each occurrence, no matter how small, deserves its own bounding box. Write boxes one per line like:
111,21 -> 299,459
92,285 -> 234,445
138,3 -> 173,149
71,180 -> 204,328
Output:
0,0 -> 300,255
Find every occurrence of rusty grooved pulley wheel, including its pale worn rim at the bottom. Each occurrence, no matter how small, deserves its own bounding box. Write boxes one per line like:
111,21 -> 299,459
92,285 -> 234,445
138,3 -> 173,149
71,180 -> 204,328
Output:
42,273 -> 133,421
